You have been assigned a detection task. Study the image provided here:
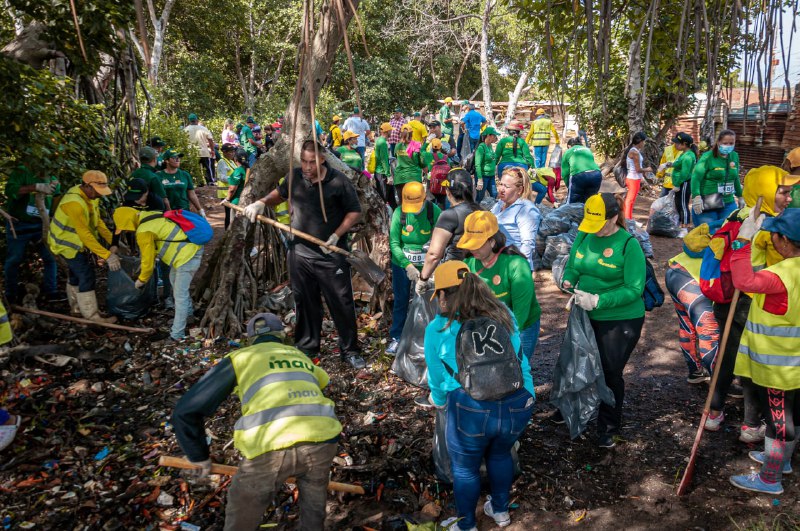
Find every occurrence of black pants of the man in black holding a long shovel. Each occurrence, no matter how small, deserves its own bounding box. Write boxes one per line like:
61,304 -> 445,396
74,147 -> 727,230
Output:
288,248 -> 360,357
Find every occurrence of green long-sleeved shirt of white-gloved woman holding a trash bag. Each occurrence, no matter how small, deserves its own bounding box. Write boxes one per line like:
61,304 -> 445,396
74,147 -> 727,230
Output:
564,229 -> 647,321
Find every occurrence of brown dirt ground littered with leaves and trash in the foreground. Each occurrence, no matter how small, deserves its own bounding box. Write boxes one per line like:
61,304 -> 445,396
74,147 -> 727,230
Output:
0,185 -> 800,531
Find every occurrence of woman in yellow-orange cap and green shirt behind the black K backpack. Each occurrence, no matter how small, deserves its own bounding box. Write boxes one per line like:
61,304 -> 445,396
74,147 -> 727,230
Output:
458,210 -> 542,361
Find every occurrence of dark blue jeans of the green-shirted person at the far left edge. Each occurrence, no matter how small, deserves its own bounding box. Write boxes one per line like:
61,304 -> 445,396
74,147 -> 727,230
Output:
3,221 -> 58,302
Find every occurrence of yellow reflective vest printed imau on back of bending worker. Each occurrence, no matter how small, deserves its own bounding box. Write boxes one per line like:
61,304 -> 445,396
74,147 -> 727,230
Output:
228,343 -> 342,459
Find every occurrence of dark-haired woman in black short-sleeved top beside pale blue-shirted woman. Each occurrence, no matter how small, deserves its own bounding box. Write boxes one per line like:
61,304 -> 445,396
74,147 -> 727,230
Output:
415,168 -> 481,294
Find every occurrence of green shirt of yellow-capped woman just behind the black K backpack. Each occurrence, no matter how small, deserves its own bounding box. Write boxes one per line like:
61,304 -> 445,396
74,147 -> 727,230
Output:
465,254 -> 542,330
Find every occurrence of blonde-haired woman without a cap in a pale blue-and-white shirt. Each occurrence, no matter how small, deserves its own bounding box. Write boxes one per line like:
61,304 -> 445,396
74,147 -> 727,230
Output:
492,167 -> 542,272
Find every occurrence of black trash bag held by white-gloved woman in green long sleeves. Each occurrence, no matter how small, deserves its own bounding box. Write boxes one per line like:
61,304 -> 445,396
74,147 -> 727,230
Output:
550,304 -> 614,439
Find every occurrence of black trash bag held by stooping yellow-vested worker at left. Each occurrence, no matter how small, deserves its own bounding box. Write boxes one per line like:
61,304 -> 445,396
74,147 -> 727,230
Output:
106,256 -> 158,321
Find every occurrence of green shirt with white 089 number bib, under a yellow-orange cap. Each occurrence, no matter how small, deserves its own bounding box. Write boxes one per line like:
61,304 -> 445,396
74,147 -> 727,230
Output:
389,201 -> 442,269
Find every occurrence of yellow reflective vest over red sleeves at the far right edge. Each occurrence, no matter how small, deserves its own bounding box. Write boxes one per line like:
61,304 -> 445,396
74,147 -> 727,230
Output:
734,258 -> 800,391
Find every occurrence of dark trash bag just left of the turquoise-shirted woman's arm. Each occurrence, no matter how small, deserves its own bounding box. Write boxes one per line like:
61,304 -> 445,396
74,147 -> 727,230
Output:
392,291 -> 439,389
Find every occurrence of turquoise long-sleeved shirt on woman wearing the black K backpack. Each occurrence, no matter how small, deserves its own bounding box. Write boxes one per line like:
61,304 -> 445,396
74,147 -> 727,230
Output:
425,315 -> 536,407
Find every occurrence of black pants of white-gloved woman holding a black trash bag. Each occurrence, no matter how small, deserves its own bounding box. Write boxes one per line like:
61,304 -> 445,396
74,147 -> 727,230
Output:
592,317 -> 644,435
